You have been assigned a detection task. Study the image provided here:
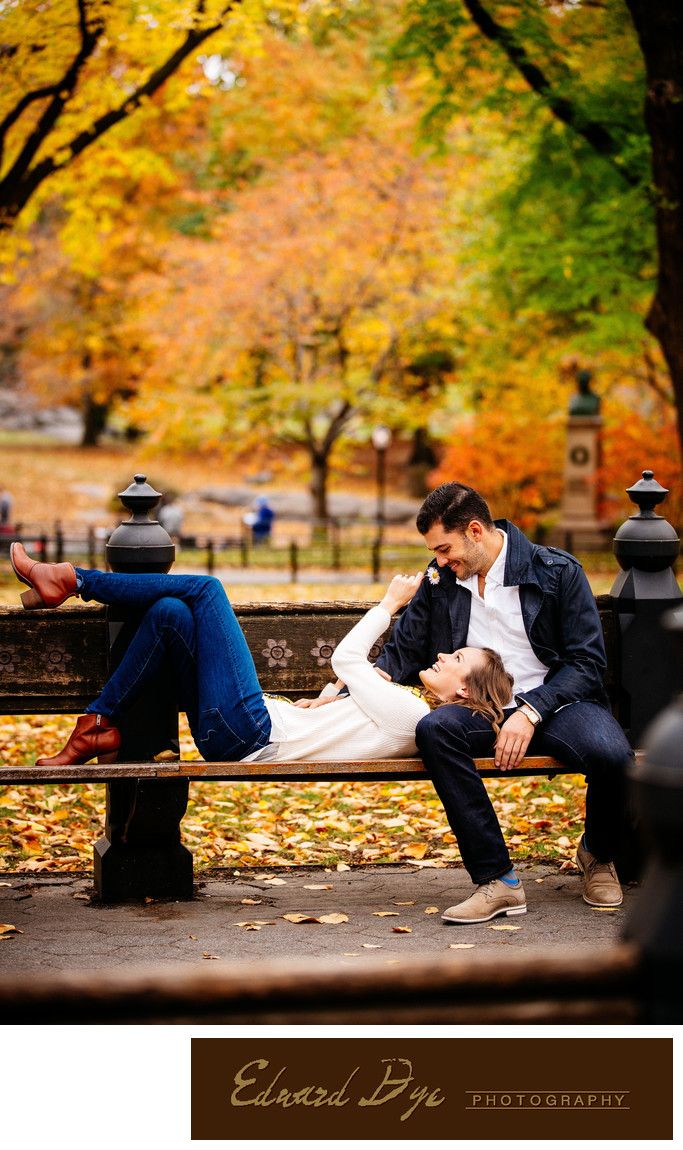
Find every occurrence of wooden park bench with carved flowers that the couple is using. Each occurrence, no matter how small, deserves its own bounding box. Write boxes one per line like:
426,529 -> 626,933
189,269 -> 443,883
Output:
0,596 -> 643,902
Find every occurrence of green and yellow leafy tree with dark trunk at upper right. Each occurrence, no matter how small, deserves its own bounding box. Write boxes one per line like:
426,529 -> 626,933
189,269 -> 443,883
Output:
394,0 -> 683,457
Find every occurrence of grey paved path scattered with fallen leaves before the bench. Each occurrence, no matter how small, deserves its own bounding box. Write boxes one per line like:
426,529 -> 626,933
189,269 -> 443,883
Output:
0,865 -> 637,975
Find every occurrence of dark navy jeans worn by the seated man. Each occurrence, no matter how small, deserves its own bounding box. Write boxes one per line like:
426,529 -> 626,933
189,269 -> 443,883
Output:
416,702 -> 632,884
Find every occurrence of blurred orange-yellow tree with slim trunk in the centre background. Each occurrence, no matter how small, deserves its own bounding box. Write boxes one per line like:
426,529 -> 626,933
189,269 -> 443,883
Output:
131,135 -> 453,520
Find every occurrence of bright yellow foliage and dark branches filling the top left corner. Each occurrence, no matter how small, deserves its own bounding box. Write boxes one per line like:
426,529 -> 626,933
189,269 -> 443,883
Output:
0,0 -> 310,231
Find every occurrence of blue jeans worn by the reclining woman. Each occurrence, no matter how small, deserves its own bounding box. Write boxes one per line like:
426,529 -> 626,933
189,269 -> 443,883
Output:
76,567 -> 270,761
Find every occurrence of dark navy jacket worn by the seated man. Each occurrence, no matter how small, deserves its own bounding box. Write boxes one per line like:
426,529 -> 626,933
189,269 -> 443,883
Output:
377,520 -> 608,719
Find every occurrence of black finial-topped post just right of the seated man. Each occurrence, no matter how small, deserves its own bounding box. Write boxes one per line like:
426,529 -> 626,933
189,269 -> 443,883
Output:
609,470 -> 683,746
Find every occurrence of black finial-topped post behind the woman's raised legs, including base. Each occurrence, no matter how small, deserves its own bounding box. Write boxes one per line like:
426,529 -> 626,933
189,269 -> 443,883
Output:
94,475 -> 192,903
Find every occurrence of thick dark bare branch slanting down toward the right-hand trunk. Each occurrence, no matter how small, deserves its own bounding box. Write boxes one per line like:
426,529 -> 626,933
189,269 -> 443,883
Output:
462,0 -> 639,187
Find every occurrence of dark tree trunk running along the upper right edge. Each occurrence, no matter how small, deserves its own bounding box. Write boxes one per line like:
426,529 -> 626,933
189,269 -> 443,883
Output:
627,0 -> 683,453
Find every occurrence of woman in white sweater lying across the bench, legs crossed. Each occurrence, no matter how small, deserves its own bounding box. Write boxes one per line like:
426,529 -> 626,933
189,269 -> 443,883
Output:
10,543 -> 512,766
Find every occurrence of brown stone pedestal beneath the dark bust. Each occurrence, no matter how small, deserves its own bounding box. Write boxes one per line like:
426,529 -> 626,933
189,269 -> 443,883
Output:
551,415 -> 611,551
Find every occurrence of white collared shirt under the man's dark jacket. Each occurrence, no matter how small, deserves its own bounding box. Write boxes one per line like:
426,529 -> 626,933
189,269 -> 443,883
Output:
458,528 -> 547,695
